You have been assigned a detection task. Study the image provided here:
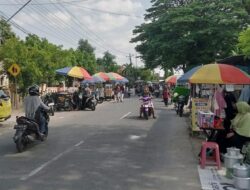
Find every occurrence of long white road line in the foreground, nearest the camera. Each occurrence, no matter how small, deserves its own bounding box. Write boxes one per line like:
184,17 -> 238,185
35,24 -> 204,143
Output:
20,141 -> 84,181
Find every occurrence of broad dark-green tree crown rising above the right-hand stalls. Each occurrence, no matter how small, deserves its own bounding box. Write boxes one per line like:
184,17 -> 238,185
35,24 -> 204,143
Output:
131,0 -> 250,70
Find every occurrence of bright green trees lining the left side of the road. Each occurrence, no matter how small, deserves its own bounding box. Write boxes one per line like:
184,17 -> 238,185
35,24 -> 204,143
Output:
0,20 -> 99,92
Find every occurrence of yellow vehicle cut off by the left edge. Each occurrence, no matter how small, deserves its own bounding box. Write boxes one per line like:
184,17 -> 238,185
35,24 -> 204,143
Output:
0,88 -> 12,122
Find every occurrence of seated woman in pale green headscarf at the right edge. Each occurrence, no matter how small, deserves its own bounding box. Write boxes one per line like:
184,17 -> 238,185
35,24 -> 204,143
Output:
218,102 -> 250,153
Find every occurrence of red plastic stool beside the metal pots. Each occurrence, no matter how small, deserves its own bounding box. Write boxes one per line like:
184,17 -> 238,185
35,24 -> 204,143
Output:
200,141 -> 221,169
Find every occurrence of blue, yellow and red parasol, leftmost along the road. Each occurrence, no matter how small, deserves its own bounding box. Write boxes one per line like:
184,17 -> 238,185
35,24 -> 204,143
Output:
56,66 -> 92,79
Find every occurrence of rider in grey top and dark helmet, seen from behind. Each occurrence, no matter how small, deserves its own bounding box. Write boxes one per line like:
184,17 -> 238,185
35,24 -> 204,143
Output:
24,85 -> 50,139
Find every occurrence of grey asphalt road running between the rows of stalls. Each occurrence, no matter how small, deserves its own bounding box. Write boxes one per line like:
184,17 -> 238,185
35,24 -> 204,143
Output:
0,98 -> 201,190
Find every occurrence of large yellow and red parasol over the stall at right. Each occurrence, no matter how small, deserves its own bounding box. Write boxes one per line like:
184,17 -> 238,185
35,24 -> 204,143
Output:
189,63 -> 250,84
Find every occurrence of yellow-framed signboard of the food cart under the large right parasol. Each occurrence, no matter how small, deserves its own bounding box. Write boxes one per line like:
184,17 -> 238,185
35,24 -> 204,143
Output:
192,98 -> 210,131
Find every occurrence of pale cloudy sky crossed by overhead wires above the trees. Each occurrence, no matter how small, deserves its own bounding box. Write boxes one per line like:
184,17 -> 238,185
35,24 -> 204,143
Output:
0,0 -> 154,70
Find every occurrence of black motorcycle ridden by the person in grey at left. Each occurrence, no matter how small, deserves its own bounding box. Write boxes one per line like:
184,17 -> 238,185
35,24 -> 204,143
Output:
13,109 -> 50,152
